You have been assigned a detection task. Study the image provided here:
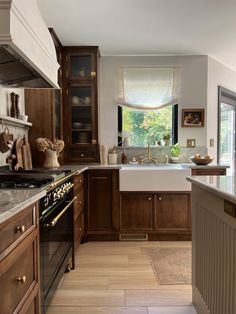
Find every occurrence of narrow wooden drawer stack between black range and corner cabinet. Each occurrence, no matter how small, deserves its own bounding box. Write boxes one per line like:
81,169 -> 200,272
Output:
73,173 -> 84,252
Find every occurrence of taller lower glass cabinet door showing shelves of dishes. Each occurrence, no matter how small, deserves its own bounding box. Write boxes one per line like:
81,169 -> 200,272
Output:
68,84 -> 94,145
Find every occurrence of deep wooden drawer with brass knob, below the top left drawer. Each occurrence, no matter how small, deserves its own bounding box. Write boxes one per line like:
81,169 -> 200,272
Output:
0,235 -> 38,314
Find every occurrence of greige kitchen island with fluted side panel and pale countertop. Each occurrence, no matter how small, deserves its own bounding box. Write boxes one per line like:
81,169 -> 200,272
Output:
187,176 -> 236,314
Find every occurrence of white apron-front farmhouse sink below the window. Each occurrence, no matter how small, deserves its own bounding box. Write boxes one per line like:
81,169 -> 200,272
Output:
119,164 -> 191,192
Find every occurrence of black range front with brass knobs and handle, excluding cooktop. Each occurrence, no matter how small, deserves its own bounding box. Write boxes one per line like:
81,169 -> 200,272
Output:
40,173 -> 74,312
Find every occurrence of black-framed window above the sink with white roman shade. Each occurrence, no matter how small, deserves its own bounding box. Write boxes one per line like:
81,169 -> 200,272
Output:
117,67 -> 180,147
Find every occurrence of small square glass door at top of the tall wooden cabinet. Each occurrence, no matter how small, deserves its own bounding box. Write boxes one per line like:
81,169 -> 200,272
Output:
68,53 -> 96,80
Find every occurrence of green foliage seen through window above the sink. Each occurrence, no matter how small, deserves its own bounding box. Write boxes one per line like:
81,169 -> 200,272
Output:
122,106 -> 172,147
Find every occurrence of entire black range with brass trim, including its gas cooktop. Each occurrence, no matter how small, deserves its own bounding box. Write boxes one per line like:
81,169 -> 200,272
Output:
0,170 -> 75,313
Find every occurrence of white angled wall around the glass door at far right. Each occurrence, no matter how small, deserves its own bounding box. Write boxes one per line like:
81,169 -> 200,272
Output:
207,57 -> 236,158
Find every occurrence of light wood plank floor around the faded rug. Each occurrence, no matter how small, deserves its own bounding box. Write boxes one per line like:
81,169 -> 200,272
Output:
48,242 -> 196,314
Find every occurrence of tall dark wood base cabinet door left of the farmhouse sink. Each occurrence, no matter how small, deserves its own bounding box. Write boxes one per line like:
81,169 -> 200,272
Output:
88,171 -> 112,231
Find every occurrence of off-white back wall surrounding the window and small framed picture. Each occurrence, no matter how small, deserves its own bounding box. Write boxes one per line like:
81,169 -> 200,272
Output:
99,56 -> 207,147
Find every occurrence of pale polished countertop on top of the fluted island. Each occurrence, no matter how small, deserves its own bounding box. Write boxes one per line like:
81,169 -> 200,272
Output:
187,176 -> 236,204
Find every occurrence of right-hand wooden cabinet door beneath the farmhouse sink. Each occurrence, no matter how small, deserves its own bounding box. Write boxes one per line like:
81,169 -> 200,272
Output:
155,193 -> 190,230
